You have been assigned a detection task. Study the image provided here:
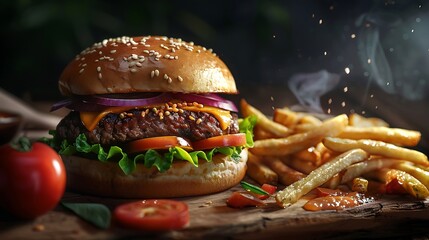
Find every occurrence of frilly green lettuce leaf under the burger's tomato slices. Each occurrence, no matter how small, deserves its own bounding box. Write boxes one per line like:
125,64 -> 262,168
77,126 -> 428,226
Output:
40,116 -> 256,175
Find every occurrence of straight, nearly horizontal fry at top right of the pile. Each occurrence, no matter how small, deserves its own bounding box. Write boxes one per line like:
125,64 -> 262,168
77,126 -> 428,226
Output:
338,126 -> 421,146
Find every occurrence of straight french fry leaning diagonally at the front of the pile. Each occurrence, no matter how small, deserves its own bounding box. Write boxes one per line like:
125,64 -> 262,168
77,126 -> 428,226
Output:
275,149 -> 368,208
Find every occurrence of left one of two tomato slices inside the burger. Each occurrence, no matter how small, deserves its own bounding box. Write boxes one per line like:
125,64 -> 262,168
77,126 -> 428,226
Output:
127,136 -> 192,153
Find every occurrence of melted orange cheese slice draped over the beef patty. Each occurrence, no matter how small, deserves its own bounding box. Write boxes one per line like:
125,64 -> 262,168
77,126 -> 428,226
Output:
80,106 -> 232,131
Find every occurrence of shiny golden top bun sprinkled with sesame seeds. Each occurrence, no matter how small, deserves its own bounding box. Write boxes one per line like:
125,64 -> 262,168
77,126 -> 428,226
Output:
59,36 -> 237,96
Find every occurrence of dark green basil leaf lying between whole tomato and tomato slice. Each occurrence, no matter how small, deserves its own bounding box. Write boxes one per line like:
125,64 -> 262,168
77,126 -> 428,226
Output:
61,202 -> 112,229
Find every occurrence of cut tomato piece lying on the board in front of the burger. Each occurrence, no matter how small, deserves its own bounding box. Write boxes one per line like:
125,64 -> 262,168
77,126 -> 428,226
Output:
113,199 -> 189,231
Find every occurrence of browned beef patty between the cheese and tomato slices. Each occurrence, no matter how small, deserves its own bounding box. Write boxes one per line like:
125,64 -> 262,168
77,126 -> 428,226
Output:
57,109 -> 239,146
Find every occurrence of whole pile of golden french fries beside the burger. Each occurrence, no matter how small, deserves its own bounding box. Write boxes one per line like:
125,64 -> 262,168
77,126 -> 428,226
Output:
240,99 -> 429,207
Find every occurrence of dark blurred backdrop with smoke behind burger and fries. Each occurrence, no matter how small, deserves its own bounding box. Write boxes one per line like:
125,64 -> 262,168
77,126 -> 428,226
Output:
0,0 -> 429,152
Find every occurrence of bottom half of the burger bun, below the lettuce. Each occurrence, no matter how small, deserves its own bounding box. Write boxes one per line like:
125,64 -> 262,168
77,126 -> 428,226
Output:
62,149 -> 248,198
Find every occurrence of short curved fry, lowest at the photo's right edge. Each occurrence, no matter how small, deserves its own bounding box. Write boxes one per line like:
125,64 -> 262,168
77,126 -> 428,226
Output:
376,169 -> 429,199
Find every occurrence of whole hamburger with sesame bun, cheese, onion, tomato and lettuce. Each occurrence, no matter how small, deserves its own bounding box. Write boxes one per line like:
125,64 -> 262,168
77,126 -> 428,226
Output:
50,36 -> 254,198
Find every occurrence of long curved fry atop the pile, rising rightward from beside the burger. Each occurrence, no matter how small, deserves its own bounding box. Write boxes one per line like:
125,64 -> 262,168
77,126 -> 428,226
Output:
250,114 -> 348,156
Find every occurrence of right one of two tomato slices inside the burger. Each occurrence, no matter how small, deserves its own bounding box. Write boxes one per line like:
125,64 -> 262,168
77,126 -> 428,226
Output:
192,133 -> 246,150
